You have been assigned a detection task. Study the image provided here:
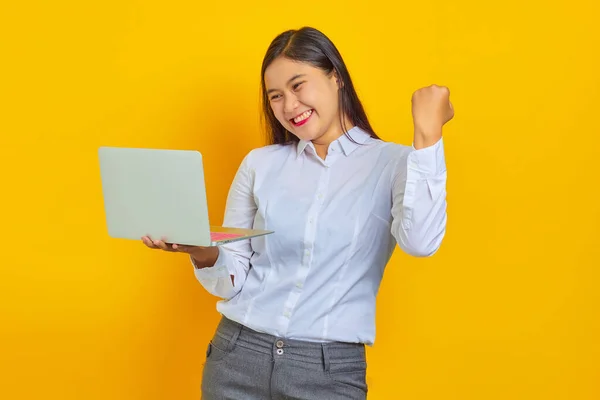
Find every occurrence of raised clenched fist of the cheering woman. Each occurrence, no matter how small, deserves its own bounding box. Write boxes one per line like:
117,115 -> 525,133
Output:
412,85 -> 454,148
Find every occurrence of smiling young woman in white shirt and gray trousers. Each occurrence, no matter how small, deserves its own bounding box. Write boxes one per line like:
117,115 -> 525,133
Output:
143,28 -> 454,400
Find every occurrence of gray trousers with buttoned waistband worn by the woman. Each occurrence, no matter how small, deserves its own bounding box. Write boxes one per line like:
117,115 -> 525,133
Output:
202,318 -> 367,400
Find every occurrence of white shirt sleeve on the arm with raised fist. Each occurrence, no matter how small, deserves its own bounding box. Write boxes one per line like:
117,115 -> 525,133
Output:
392,139 -> 447,257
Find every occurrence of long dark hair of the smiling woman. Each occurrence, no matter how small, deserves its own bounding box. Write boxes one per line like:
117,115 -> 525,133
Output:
261,27 -> 379,144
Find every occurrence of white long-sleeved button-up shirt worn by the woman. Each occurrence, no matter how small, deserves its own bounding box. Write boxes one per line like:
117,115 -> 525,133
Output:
195,127 -> 446,345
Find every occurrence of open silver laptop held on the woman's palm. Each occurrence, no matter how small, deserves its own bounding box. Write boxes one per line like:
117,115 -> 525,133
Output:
98,146 -> 273,246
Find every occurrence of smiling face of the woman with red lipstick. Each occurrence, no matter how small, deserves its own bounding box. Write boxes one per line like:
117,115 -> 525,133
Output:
264,57 -> 342,143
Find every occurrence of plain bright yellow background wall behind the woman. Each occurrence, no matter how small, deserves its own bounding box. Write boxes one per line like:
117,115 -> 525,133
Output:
0,0 -> 600,400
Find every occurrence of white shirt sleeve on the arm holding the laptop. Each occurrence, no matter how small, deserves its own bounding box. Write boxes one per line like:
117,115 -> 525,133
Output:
192,155 -> 257,299
